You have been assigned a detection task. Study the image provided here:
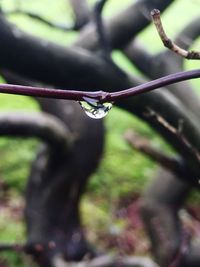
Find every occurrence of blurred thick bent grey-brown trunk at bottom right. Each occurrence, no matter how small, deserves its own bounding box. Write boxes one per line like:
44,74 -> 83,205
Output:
141,170 -> 191,267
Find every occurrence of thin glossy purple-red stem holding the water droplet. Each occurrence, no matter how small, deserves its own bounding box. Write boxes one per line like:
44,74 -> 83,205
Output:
0,69 -> 200,103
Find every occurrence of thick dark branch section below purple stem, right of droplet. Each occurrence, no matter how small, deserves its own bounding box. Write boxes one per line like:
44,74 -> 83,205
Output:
119,85 -> 200,187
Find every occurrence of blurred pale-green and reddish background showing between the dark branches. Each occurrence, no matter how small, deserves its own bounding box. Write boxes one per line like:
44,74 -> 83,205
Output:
0,0 -> 200,267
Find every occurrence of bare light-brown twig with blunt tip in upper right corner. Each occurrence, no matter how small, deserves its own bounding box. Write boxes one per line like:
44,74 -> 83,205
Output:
151,9 -> 200,59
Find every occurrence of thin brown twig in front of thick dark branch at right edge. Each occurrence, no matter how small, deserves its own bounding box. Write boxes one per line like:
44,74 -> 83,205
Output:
146,108 -> 200,162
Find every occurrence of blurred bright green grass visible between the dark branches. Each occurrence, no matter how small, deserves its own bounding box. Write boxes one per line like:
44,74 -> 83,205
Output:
0,0 -> 200,266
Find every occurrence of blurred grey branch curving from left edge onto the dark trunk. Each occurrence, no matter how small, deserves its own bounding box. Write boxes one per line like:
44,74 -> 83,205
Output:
0,112 -> 72,152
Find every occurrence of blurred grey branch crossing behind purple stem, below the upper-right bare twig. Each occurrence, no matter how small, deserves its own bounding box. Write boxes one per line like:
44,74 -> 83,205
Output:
124,38 -> 200,117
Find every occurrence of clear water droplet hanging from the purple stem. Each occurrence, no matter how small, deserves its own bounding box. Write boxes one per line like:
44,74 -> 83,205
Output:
79,97 -> 112,119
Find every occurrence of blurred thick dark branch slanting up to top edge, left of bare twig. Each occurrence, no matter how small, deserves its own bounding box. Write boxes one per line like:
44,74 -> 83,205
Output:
75,0 -> 174,50
